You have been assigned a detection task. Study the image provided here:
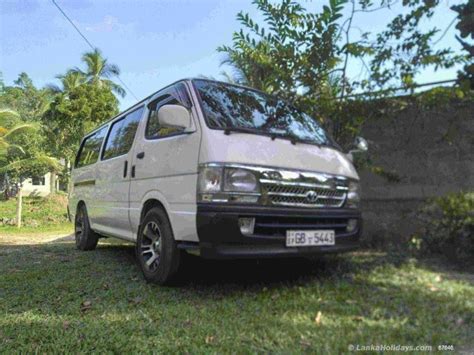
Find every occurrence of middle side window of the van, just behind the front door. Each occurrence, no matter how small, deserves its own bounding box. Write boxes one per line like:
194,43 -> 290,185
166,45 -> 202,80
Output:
102,107 -> 143,160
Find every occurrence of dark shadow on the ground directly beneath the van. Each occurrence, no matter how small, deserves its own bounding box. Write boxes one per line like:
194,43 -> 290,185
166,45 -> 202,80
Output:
89,238 -> 406,295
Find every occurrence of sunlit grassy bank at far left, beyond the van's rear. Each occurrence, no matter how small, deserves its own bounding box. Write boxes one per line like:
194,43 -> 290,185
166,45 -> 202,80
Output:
0,193 -> 72,234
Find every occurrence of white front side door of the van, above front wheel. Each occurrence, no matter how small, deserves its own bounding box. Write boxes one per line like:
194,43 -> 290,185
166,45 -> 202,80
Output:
130,82 -> 201,240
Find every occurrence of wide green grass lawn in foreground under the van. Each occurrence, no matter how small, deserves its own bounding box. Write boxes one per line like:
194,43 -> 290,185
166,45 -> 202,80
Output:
0,234 -> 474,353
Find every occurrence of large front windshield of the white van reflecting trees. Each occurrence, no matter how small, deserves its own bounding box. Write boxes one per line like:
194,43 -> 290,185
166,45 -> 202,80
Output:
193,79 -> 337,147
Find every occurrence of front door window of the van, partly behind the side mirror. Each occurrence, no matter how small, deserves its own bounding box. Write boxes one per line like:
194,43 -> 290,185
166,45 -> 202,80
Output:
145,83 -> 191,139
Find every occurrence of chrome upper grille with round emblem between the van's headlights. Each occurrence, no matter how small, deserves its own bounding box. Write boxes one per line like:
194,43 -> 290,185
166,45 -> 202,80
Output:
261,180 -> 347,208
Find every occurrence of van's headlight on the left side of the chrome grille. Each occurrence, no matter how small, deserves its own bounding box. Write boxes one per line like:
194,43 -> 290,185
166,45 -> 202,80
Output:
197,165 -> 260,203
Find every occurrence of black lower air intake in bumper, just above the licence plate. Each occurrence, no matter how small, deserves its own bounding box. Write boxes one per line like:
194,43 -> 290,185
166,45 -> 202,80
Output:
254,216 -> 348,237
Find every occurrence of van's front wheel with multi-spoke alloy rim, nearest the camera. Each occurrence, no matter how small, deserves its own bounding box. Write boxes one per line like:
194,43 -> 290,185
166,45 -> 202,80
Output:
136,207 -> 181,285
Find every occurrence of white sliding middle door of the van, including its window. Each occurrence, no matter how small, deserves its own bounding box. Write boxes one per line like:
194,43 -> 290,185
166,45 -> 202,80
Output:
95,106 -> 144,239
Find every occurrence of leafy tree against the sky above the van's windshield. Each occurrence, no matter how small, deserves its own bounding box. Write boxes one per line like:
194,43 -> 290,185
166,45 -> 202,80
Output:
218,0 -> 462,139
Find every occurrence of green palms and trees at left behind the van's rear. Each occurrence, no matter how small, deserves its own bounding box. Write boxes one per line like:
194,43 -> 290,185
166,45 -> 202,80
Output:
0,49 -> 125,193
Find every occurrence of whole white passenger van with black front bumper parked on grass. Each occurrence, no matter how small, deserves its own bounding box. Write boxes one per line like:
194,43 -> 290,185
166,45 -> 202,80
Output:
69,79 -> 367,284
